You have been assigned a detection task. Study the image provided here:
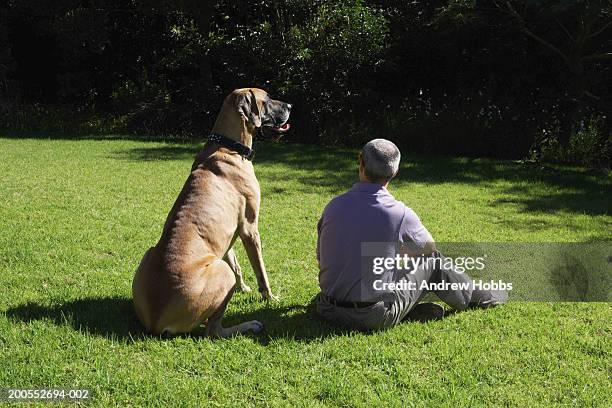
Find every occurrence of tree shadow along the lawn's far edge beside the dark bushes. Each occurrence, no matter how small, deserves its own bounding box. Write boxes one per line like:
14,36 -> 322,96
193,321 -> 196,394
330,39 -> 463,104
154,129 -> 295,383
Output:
111,142 -> 612,215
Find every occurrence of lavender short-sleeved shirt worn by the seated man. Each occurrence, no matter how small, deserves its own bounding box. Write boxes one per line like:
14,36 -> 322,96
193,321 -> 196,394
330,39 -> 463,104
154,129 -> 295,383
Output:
317,182 -> 433,302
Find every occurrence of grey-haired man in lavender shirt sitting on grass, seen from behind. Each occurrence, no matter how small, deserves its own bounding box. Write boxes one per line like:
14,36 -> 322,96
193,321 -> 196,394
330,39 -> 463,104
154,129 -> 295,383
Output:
316,139 -> 508,329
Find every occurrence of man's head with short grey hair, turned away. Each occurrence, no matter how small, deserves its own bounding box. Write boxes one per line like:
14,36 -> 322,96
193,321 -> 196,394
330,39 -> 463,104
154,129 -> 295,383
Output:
361,139 -> 401,182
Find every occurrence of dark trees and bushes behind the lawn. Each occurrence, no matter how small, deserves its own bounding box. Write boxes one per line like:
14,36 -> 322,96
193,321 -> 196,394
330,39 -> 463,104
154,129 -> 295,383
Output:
0,0 -> 612,166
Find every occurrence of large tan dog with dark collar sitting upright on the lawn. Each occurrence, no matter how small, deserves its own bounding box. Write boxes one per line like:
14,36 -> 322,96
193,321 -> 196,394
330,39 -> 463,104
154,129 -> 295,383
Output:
132,88 -> 291,337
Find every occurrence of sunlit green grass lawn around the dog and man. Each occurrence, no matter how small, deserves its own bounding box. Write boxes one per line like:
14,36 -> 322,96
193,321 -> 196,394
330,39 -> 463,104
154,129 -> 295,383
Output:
0,138 -> 612,407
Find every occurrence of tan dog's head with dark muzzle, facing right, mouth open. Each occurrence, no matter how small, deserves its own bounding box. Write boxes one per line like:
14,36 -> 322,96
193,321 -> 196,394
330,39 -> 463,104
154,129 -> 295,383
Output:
230,88 -> 291,133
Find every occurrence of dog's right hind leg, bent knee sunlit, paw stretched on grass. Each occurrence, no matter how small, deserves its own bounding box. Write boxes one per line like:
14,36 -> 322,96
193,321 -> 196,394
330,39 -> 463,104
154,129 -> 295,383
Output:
202,260 -> 263,337
